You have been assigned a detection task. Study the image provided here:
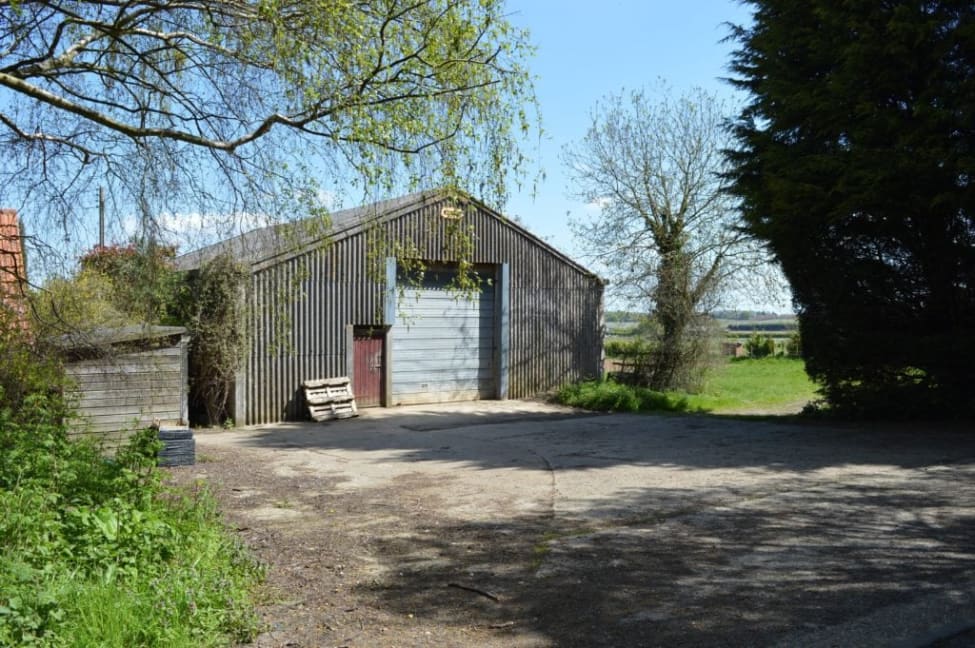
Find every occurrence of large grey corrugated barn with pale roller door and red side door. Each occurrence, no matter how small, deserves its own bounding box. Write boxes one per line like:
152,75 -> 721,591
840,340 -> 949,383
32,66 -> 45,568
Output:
178,192 -> 603,424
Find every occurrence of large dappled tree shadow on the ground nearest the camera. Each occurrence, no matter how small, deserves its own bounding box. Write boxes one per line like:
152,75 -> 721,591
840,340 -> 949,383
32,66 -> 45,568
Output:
364,466 -> 975,646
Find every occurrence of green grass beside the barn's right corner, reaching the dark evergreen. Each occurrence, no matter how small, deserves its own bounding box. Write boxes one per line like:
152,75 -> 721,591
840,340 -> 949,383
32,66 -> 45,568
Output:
557,358 -> 816,414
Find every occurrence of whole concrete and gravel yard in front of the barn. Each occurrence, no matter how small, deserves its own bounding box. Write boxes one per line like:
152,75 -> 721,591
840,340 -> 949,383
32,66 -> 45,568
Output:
172,401 -> 975,646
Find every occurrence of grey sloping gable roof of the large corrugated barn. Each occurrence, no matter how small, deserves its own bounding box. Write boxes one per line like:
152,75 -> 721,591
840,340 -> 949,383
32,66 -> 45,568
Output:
176,190 -> 603,282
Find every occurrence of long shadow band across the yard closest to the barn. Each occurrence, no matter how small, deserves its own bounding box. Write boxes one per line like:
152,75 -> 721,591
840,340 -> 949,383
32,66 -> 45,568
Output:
229,408 -> 975,471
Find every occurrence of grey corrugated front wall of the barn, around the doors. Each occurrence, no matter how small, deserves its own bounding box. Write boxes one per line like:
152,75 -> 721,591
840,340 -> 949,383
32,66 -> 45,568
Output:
238,201 -> 603,424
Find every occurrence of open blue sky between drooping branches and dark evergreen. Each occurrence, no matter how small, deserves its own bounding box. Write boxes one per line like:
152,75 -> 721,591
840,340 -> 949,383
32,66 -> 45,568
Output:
503,0 -> 790,311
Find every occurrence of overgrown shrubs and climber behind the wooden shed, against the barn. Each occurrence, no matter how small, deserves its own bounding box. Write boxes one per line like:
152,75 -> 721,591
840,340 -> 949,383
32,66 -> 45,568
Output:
31,241 -> 254,425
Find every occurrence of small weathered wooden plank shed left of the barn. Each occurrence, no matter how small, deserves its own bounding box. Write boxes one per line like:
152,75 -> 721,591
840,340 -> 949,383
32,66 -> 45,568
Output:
60,326 -> 189,446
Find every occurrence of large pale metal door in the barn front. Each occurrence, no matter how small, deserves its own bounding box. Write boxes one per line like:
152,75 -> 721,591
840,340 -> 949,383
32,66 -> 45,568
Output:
392,270 -> 498,405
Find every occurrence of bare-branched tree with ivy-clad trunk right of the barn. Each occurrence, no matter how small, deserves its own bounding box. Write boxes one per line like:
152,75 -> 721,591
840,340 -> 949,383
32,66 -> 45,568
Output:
563,88 -> 766,389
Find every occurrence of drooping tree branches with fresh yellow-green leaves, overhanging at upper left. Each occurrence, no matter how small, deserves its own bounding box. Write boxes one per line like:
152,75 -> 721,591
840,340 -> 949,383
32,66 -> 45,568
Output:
0,0 -> 534,264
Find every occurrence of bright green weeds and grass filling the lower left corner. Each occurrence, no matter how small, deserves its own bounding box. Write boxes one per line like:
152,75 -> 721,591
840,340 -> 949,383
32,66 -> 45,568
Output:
0,308 -> 261,647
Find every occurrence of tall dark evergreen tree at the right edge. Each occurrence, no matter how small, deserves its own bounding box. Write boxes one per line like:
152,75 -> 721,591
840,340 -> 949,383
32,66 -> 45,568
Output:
729,0 -> 975,415
